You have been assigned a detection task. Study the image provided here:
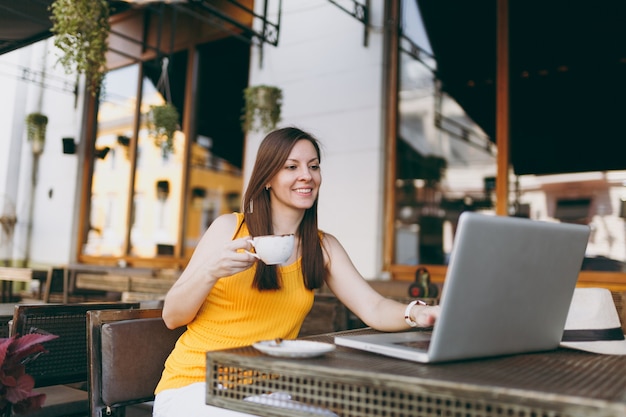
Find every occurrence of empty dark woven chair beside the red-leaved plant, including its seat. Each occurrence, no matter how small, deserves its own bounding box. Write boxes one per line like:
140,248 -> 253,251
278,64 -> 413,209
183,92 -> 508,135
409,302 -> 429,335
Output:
10,302 -> 139,417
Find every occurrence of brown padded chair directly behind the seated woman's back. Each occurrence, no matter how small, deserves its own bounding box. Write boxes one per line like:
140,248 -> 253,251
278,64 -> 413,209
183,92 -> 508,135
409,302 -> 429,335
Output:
87,309 -> 185,417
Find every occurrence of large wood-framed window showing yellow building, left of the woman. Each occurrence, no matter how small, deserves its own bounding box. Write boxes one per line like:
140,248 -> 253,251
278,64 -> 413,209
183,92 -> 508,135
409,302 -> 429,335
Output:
80,38 -> 250,266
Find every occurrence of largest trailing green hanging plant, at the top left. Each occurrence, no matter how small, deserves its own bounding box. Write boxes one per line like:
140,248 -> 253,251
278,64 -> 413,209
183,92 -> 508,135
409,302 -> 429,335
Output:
50,0 -> 111,95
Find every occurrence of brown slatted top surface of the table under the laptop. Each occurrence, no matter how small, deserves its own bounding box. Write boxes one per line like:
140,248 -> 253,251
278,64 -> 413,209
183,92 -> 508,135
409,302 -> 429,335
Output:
207,329 -> 626,415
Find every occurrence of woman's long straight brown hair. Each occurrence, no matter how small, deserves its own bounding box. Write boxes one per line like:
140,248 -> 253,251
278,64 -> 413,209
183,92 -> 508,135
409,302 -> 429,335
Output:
242,127 -> 327,290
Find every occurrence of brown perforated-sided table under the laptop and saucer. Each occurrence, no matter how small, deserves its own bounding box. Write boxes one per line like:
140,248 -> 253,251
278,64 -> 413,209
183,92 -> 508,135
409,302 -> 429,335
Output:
206,329 -> 626,417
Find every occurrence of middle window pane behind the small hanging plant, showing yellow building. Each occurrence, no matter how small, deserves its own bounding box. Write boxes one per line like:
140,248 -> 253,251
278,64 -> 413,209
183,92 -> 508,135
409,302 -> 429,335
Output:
130,53 -> 187,258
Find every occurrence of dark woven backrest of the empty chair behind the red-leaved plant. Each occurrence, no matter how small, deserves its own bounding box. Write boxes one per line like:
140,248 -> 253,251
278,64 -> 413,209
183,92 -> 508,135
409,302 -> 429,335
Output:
10,302 -> 139,387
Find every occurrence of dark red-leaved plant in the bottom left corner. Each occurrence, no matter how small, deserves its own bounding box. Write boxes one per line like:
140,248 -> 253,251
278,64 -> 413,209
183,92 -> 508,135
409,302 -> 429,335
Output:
0,333 -> 58,417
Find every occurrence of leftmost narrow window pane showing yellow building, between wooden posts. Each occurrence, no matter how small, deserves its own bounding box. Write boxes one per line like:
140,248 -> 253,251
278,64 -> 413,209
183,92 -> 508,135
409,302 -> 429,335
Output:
83,65 -> 139,256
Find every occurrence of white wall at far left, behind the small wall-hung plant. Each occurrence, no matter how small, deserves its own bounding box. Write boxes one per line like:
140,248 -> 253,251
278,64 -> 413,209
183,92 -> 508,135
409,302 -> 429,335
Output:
0,39 -> 82,265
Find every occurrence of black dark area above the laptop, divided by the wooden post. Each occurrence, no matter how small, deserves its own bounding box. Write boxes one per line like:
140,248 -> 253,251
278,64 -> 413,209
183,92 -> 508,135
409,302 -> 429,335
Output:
417,0 -> 626,174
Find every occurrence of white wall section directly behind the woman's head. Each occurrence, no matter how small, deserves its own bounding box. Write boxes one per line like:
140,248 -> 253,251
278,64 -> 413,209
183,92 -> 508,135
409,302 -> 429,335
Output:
244,0 -> 385,278
